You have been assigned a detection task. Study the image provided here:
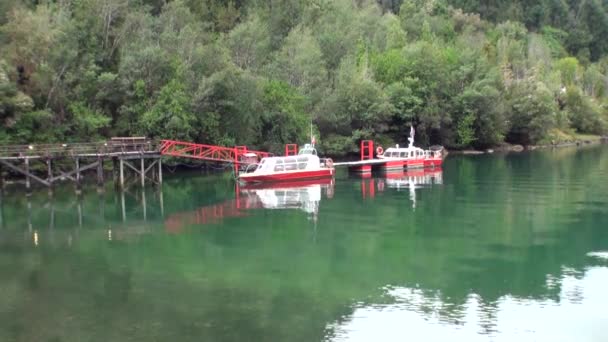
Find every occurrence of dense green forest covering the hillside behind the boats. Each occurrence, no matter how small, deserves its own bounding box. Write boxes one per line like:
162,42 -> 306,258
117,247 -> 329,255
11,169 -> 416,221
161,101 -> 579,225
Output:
0,0 -> 608,156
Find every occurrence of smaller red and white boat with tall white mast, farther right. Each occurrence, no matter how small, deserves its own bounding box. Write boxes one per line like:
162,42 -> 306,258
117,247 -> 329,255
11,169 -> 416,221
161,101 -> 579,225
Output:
377,127 -> 443,169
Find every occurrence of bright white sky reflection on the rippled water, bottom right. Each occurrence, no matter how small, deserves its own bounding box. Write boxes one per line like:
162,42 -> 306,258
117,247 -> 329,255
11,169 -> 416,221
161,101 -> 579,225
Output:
325,267 -> 608,342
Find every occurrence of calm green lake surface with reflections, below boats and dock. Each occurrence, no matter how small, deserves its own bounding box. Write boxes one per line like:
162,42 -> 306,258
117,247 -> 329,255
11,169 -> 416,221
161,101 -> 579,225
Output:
0,146 -> 608,342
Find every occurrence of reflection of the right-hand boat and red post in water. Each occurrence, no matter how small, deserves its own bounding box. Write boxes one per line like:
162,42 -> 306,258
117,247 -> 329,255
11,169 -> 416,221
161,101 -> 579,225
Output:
361,167 -> 443,209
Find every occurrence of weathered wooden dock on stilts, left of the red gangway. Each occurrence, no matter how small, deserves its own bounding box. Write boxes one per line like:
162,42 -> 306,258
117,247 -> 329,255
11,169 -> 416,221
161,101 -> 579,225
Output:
0,137 -> 162,190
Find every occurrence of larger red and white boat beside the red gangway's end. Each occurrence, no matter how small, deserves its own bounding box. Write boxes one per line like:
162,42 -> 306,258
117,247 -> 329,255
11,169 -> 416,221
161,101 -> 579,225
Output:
238,144 -> 335,183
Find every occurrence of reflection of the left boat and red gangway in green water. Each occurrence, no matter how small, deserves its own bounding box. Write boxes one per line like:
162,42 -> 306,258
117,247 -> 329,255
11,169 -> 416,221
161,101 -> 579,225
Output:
165,178 -> 334,233
